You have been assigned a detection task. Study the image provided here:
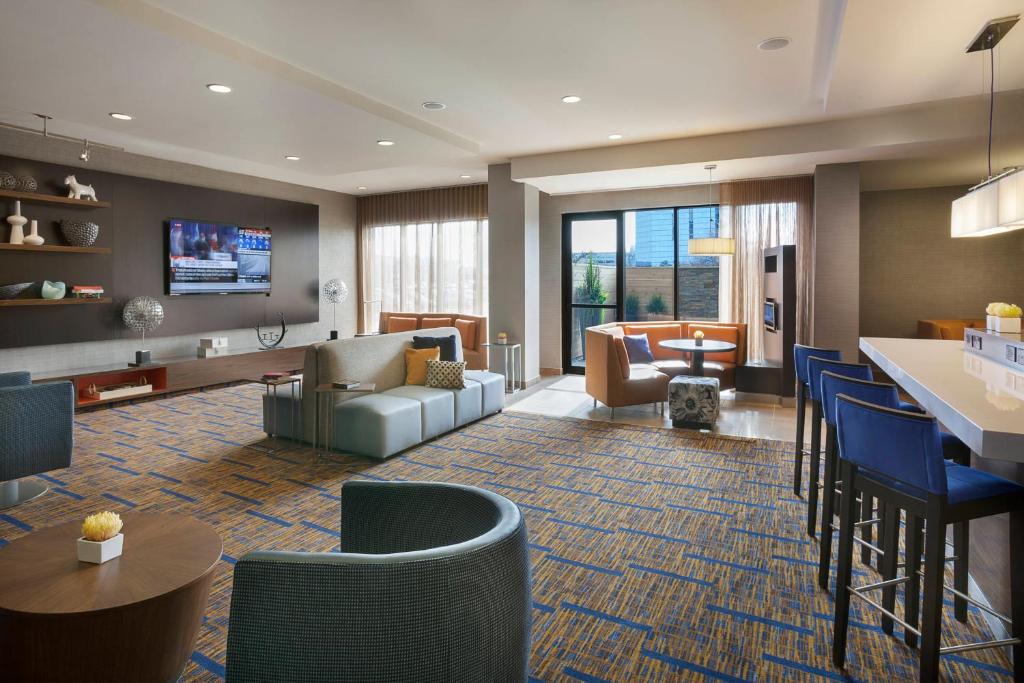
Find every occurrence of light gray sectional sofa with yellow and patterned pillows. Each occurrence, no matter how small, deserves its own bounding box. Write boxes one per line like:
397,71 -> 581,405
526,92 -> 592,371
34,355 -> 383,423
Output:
263,328 -> 505,460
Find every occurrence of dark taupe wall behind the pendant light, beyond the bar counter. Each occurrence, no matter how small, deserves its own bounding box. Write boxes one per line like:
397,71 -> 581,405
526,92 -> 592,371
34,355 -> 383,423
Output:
860,186 -> 1024,337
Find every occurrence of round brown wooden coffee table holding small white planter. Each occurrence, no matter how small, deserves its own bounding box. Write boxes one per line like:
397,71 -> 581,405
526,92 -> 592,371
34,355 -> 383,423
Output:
0,512 -> 223,681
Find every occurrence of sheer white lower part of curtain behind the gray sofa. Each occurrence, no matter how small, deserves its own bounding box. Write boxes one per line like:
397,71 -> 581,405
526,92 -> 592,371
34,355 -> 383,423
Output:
361,220 -> 487,330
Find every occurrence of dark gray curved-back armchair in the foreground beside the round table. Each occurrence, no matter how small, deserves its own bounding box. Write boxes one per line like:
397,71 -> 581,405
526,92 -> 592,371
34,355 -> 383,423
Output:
226,481 -> 531,682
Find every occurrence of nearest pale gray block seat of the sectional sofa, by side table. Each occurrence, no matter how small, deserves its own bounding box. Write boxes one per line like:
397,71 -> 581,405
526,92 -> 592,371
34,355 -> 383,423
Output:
332,391 -> 423,460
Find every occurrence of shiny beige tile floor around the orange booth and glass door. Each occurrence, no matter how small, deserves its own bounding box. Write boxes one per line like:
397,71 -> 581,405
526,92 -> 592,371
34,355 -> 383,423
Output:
506,375 -> 810,441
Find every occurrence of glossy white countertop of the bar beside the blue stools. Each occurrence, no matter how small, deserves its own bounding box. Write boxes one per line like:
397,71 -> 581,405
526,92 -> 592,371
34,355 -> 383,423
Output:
860,337 -> 1024,463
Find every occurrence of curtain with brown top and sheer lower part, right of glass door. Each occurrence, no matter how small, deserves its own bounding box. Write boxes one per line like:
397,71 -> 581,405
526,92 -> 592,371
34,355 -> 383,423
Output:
719,175 -> 814,360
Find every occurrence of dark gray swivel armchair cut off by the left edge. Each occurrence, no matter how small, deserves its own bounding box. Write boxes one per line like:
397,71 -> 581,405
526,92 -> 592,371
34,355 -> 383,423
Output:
0,372 -> 75,508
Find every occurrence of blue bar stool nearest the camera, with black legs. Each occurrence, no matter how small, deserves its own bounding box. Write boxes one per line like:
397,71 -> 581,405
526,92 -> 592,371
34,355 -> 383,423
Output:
833,394 -> 1024,681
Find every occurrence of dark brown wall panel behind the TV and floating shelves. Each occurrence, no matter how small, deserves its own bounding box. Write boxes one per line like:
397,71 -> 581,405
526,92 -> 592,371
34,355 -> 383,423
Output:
0,157 -> 319,348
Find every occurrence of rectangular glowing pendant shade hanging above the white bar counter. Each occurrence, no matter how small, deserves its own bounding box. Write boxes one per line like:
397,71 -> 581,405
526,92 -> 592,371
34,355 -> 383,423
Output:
949,169 -> 1024,238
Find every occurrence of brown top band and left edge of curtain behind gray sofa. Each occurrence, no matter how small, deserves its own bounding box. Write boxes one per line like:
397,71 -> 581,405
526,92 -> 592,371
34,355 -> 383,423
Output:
355,184 -> 487,331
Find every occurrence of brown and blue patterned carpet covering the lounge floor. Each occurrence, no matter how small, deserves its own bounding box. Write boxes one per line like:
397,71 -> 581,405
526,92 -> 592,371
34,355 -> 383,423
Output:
0,385 -> 1010,681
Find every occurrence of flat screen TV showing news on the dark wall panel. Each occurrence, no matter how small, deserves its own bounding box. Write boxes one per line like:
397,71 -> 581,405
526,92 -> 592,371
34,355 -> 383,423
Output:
167,218 -> 270,295
